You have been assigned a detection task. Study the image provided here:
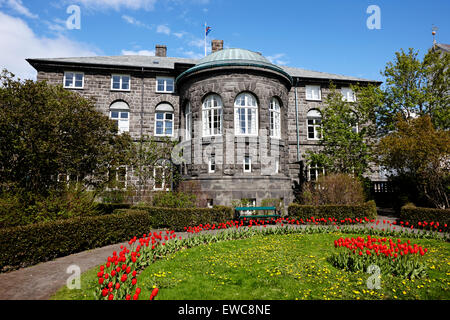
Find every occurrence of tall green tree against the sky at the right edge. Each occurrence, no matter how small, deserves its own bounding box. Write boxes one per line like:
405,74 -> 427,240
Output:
371,48 -> 450,134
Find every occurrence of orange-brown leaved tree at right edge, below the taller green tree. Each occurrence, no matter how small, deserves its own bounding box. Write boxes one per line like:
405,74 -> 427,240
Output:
376,115 -> 450,208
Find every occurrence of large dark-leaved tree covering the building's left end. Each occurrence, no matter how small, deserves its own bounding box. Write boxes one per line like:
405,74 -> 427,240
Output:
0,70 -> 132,195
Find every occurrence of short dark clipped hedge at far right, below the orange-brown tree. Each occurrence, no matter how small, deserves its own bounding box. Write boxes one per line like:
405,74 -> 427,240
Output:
399,205 -> 450,225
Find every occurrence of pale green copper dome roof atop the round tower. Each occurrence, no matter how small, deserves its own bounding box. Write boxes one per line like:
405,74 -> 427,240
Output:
176,49 -> 292,83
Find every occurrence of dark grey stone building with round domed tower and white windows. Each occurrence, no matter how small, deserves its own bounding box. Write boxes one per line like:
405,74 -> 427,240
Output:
27,40 -> 379,205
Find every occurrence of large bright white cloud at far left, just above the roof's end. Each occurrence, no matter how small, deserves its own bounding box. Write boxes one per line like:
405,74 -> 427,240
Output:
0,12 -> 96,79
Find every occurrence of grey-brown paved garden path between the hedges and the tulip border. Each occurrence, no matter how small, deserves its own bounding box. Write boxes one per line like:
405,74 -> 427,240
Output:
0,216 -> 404,300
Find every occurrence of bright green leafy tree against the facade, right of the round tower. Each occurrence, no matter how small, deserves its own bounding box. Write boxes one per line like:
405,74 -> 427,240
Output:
307,84 -> 375,177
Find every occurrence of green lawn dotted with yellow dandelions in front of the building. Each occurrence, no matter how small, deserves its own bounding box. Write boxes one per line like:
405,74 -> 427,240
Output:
53,233 -> 450,300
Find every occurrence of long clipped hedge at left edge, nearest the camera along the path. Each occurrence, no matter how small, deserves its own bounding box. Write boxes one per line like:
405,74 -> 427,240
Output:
0,210 -> 152,271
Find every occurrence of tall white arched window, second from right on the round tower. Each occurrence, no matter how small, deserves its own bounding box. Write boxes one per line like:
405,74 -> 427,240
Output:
234,93 -> 258,136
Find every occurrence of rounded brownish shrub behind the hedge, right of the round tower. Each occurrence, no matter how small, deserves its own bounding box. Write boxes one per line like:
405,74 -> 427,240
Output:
301,174 -> 365,206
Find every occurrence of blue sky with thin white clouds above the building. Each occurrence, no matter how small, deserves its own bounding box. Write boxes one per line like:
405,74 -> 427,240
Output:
0,0 -> 450,80
